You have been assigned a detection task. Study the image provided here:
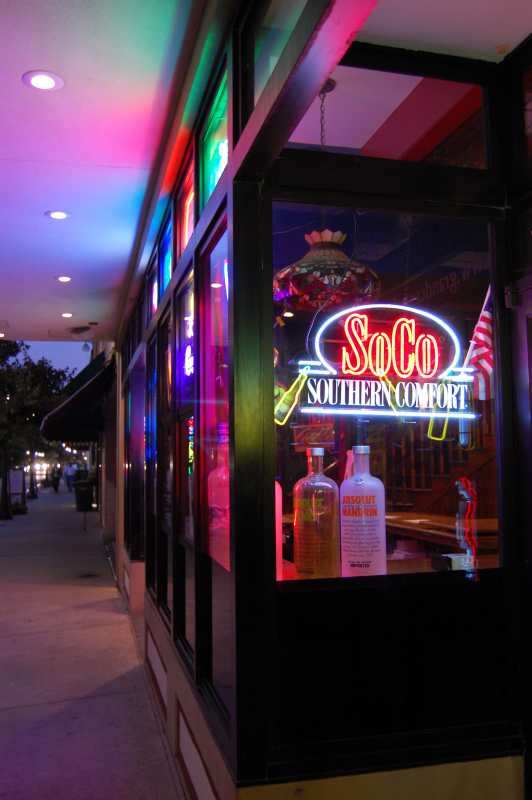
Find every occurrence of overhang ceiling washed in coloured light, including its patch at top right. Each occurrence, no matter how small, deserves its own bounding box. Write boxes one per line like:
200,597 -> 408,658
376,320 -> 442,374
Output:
0,0 -> 532,341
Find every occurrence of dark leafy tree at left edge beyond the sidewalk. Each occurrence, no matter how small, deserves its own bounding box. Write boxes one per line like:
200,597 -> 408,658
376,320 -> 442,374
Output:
0,341 -> 74,519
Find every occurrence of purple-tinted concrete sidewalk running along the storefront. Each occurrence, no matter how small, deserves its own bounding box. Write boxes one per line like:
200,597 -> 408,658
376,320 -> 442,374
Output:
0,485 -> 184,800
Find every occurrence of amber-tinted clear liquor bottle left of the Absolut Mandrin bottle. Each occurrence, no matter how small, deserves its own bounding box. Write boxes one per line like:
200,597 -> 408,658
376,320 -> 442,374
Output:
294,447 -> 340,578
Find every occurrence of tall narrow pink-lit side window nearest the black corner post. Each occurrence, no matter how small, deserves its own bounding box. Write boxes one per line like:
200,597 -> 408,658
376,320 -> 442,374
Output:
201,233 -> 231,706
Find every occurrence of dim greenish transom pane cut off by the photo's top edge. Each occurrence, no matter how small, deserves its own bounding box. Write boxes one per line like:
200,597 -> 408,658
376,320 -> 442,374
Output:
254,0 -> 307,104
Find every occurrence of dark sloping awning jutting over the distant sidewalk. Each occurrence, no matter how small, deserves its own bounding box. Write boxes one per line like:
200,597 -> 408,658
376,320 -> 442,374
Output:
41,356 -> 116,444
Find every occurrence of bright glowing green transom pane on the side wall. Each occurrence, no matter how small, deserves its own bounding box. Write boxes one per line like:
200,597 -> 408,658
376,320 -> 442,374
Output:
201,75 -> 225,208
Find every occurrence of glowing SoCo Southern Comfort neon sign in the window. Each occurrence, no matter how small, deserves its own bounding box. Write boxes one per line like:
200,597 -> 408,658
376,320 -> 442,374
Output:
299,303 -> 475,419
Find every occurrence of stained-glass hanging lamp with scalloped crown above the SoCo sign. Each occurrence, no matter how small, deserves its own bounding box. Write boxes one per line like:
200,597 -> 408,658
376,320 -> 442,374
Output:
273,229 -> 380,312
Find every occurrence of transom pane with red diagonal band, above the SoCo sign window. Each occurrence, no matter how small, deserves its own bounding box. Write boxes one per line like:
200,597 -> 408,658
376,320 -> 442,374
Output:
289,66 -> 486,169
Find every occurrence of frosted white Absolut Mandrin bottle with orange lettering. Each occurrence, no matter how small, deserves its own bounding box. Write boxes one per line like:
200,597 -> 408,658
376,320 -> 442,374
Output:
340,445 -> 386,578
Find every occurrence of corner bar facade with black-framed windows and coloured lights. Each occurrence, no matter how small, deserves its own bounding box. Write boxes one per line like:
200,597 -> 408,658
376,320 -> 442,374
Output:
117,0 -> 532,800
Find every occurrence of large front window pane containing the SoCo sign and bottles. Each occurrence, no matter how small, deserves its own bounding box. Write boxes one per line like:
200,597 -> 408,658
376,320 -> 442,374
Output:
273,203 -> 499,580
